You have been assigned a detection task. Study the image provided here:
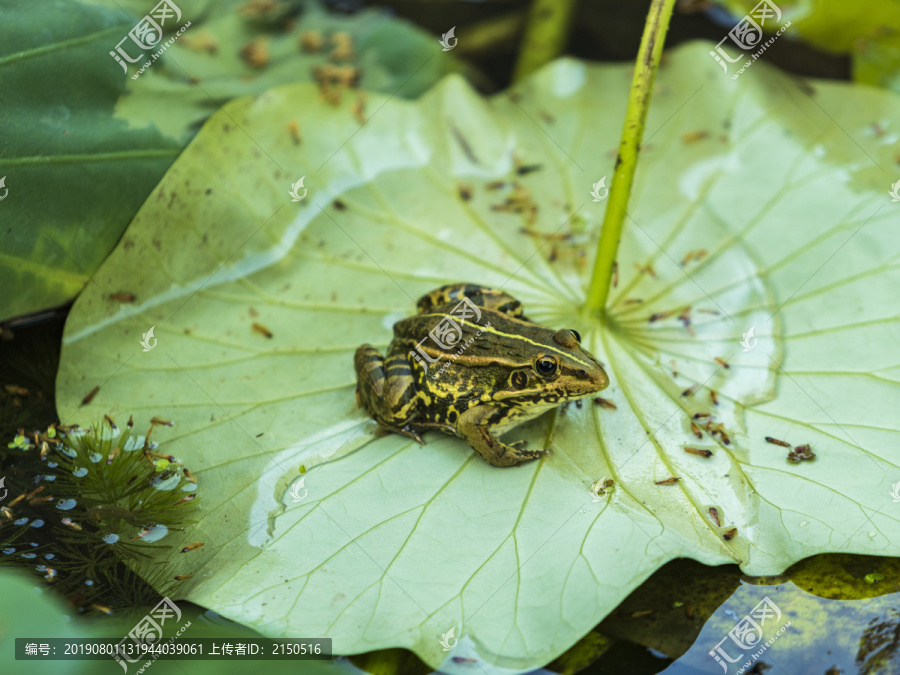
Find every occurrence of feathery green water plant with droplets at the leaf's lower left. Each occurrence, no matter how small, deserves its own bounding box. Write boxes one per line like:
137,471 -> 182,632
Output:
0,416 -> 197,614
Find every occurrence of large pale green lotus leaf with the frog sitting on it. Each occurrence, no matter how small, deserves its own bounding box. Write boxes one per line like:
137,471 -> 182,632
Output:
57,44 -> 900,670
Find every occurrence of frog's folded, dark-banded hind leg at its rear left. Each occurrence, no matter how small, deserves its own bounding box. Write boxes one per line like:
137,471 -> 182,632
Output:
353,345 -> 422,443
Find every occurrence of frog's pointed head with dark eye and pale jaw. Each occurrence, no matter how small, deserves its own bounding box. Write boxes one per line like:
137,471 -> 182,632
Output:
493,329 -> 609,407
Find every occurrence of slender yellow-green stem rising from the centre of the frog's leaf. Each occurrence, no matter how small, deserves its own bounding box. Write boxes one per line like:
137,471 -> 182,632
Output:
583,0 -> 675,316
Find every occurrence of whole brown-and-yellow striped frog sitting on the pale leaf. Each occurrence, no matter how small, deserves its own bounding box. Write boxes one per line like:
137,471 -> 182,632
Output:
354,283 -> 609,467
